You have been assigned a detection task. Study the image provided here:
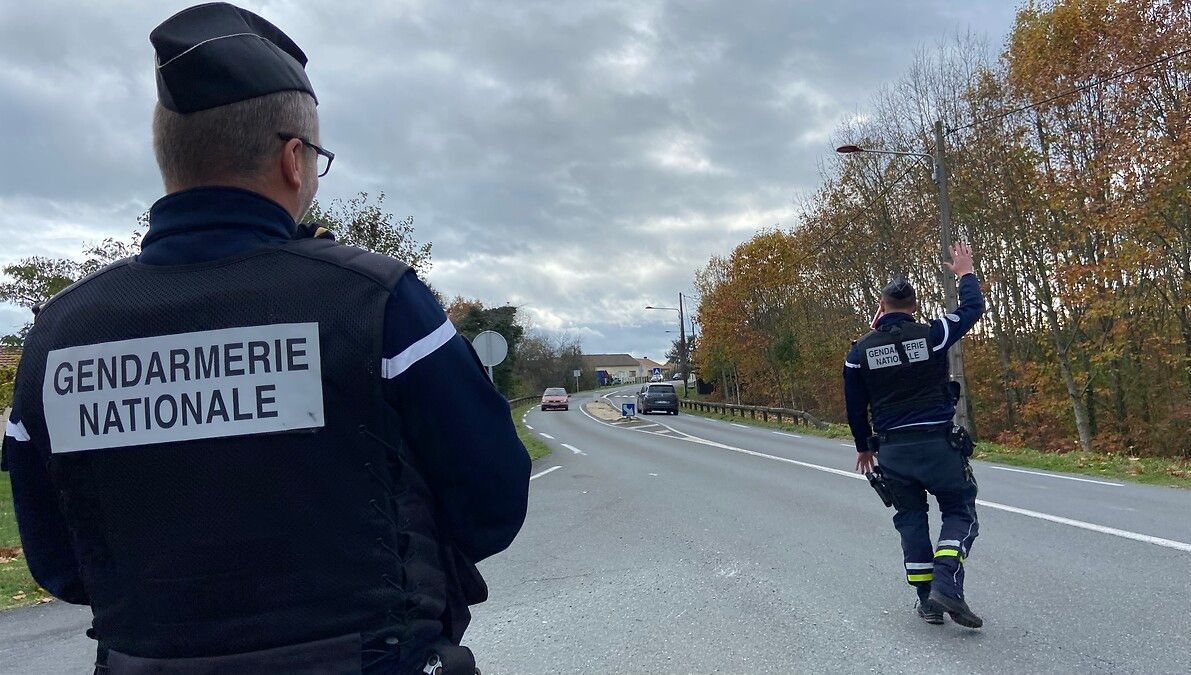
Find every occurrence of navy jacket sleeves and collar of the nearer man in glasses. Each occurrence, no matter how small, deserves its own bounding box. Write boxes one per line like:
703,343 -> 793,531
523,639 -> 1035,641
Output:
4,188 -> 530,604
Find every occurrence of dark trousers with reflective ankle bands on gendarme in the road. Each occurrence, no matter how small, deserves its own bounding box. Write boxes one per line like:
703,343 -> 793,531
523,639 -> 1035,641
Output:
878,431 -> 980,599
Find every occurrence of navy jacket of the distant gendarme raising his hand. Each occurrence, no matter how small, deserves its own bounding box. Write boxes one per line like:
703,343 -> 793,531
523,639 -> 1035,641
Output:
843,274 -> 984,452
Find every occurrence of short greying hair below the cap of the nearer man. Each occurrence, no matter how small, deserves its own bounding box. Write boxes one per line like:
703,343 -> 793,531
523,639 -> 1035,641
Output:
152,92 -> 318,188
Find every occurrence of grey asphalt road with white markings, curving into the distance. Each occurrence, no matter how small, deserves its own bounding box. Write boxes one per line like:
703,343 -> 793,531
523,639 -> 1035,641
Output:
0,390 -> 1191,674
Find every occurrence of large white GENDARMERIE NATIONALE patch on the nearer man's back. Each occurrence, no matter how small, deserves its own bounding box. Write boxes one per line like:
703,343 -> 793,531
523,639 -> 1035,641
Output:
42,323 -> 324,452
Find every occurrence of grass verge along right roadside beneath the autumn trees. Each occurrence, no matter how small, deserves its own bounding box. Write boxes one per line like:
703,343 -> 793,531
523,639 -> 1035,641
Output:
682,408 -> 1191,489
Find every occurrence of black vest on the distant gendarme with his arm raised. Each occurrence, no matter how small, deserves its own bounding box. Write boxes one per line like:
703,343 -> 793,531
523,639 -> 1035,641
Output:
856,321 -> 950,418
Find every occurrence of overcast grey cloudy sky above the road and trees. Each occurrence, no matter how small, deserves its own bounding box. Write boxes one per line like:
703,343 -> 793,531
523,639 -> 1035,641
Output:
0,0 -> 1015,360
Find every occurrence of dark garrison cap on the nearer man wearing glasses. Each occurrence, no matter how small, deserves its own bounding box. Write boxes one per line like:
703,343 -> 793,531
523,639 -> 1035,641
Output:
149,2 -> 318,113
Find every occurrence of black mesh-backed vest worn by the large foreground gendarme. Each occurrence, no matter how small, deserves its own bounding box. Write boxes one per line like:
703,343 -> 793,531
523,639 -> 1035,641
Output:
21,239 -> 464,660
